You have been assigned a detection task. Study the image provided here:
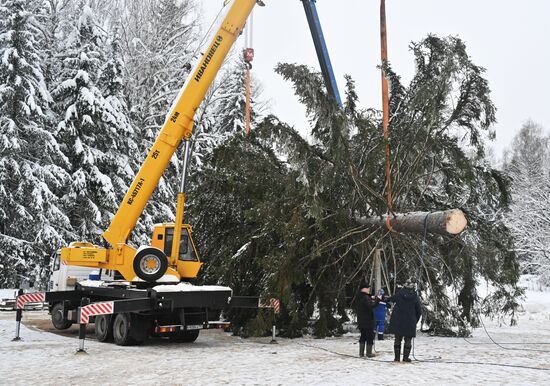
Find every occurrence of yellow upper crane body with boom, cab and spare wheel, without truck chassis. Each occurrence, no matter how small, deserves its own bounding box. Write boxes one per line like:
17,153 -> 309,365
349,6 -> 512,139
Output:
61,0 -> 264,282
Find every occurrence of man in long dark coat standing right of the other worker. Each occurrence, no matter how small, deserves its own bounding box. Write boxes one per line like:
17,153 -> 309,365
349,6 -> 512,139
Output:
386,279 -> 421,362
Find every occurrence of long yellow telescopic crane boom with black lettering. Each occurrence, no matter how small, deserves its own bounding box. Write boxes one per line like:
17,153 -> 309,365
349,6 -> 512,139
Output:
103,0 -> 256,247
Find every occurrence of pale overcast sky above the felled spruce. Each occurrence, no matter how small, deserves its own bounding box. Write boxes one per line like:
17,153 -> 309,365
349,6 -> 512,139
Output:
203,0 -> 550,155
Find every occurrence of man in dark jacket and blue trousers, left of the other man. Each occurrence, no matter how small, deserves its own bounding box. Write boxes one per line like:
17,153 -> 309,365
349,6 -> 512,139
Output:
356,284 -> 379,358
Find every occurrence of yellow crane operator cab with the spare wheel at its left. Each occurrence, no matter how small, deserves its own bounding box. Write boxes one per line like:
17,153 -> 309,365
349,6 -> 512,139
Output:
134,223 -> 202,282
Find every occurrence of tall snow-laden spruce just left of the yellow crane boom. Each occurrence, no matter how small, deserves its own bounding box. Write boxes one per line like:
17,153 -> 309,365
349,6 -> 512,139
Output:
53,4 -> 135,243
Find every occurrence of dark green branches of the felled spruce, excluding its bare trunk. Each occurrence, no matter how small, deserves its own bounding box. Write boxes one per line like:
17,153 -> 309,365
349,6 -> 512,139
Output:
193,36 -> 521,336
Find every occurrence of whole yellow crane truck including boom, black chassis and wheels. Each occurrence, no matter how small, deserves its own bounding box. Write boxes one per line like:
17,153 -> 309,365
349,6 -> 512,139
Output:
41,0 -> 264,345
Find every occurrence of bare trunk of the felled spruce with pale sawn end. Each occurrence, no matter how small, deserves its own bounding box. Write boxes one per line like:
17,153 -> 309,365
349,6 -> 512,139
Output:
356,209 -> 468,235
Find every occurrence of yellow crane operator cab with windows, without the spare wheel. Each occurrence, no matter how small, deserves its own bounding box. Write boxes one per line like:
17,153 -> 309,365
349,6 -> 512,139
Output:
151,223 -> 202,279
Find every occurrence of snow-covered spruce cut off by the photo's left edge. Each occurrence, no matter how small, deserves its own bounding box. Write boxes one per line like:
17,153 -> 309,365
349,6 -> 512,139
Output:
0,0 -> 70,286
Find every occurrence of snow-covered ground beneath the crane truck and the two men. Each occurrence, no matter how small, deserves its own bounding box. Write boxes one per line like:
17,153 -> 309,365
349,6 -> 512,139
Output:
0,282 -> 550,385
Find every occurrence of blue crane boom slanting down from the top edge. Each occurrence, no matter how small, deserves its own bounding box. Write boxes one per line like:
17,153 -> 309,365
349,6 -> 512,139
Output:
301,0 -> 342,106
